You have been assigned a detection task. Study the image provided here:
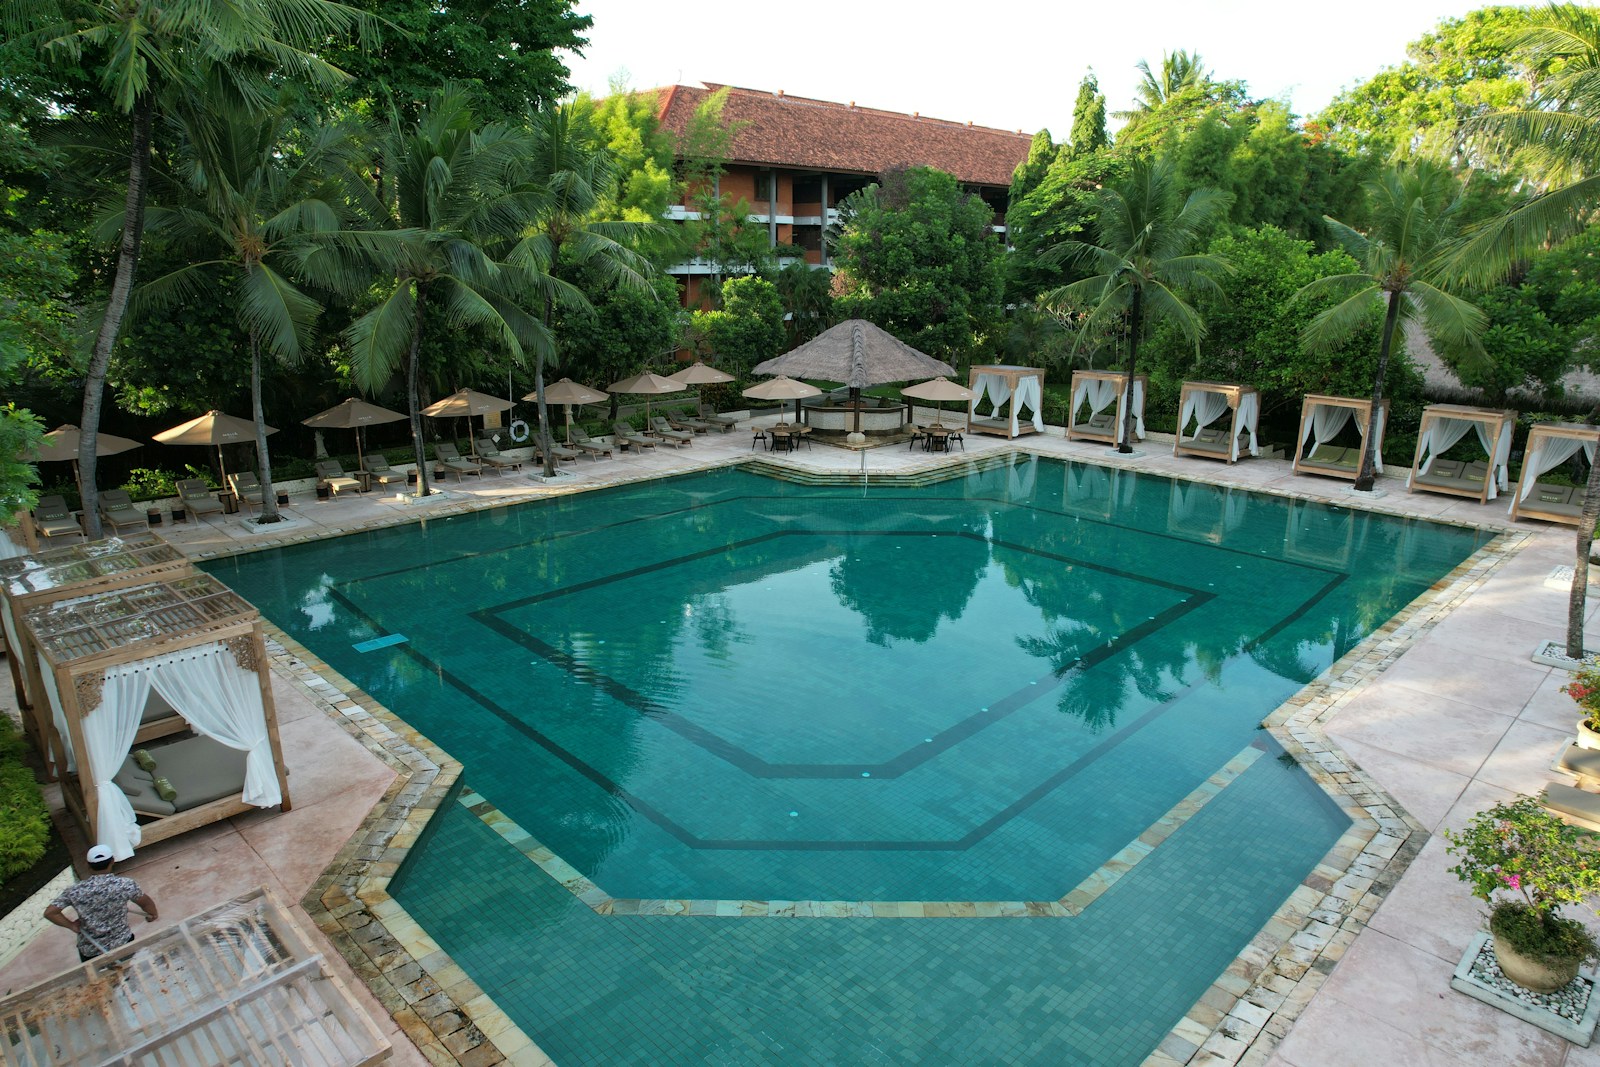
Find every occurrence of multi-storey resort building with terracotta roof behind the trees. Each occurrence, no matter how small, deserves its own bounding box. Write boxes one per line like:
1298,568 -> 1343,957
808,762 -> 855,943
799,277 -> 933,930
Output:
654,82 -> 1032,306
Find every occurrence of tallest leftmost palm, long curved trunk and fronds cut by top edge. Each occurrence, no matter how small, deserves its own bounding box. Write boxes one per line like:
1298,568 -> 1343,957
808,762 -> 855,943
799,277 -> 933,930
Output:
0,0 -> 371,537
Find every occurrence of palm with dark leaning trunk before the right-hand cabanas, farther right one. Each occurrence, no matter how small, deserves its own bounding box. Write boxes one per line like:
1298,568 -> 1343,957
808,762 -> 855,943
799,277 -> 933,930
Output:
1294,160 -> 1485,493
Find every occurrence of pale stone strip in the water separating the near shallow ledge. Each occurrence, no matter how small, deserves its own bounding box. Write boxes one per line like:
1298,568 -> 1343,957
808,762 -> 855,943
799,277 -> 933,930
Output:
458,744 -> 1262,918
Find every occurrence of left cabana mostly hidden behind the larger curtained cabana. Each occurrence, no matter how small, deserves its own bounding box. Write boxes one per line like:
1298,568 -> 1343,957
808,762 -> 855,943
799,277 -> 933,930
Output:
0,533 -> 194,781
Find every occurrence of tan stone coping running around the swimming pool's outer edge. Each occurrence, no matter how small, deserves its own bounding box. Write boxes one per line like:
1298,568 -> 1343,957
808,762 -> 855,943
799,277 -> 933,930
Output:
179,438 -> 1531,1067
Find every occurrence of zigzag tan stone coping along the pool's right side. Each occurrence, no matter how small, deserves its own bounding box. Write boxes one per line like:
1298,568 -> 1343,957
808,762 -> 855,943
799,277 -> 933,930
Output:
1144,530 -> 1531,1067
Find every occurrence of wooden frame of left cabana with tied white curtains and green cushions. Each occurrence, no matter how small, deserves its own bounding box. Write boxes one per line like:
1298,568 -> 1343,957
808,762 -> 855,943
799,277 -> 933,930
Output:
22,571 -> 290,845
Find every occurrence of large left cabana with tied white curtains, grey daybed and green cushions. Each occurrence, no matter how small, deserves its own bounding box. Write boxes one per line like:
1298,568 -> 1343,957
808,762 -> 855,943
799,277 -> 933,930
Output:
22,573 -> 290,859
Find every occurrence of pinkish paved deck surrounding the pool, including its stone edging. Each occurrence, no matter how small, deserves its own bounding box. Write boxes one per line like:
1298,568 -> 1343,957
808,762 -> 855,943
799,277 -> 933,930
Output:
0,418 -> 1600,1067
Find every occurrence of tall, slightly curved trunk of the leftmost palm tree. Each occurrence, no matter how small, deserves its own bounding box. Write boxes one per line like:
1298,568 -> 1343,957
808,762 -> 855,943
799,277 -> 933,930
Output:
78,93 -> 155,541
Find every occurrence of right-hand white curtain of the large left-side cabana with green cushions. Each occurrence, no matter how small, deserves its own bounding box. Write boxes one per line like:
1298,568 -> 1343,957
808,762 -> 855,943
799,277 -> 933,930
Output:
148,643 -> 283,808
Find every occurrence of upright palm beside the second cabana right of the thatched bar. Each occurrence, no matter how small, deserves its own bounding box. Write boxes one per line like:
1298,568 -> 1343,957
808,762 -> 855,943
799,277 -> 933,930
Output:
1040,160 -> 1234,453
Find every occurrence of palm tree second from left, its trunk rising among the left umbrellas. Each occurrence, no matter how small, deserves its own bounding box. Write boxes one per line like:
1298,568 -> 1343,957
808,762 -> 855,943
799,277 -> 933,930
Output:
134,107 -> 360,523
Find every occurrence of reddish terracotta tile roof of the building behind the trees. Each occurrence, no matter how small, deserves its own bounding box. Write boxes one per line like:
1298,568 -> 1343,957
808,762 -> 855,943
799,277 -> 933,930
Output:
653,82 -> 1032,186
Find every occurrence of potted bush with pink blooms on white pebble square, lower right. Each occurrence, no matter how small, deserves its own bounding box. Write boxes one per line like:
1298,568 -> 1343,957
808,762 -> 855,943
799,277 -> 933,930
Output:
1445,797 -> 1600,993
